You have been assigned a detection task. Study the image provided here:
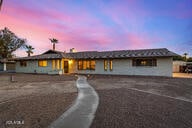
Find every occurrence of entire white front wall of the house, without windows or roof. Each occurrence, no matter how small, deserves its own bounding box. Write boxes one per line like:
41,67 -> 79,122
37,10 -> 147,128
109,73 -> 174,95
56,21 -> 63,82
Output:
16,57 -> 173,76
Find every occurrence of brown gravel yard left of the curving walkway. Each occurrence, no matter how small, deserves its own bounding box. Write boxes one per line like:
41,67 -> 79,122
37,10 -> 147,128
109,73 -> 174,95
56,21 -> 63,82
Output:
0,74 -> 77,128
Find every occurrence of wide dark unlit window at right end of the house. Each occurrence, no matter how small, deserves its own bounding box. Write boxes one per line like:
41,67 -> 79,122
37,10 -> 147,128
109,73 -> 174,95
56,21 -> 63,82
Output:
133,59 -> 157,66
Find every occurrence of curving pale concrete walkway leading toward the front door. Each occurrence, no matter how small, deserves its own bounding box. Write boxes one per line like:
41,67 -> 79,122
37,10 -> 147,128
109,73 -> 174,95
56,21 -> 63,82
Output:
48,76 -> 99,128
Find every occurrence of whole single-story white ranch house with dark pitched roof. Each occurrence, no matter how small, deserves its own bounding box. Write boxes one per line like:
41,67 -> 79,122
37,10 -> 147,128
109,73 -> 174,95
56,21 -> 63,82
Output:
15,48 -> 177,76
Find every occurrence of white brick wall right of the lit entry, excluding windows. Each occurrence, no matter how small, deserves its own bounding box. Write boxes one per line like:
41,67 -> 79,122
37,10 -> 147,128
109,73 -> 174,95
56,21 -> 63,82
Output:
75,57 -> 172,76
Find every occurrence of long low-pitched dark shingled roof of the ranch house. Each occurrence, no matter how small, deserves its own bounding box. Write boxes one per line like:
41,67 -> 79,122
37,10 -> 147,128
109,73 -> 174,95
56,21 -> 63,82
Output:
13,48 -> 178,60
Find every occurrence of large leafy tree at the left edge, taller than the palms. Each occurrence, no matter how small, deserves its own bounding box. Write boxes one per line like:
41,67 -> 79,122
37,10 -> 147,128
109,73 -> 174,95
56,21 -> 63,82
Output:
0,27 -> 26,58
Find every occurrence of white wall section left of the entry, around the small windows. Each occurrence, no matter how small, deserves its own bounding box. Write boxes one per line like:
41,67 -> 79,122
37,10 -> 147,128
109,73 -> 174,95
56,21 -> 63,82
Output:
16,60 -> 52,74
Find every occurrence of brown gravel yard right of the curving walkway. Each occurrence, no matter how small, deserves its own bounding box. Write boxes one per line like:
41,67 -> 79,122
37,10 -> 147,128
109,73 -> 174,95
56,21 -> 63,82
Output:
88,75 -> 192,128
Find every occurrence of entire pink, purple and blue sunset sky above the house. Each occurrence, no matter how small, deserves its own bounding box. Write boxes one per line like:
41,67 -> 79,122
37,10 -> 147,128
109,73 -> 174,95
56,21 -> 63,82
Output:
0,0 -> 192,56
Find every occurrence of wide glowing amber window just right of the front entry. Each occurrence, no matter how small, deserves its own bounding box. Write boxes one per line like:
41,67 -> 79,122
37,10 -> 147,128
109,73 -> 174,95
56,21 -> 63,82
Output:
78,60 -> 95,70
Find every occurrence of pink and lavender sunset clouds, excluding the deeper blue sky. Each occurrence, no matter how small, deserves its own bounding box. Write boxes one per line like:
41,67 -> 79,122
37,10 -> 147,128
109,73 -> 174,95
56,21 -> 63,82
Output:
0,0 -> 184,55
